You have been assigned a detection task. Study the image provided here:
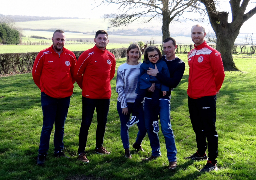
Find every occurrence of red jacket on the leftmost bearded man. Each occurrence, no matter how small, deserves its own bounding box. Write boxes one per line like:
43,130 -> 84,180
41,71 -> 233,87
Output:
32,46 -> 77,98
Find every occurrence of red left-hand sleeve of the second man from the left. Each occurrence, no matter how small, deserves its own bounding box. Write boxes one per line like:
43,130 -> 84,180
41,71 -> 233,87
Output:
74,52 -> 91,89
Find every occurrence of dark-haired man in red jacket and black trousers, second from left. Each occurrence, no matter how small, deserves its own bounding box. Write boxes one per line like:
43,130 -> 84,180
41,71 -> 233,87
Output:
75,30 -> 116,163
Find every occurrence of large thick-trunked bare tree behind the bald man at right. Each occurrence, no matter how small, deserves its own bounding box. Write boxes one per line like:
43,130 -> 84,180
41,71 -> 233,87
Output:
200,0 -> 256,71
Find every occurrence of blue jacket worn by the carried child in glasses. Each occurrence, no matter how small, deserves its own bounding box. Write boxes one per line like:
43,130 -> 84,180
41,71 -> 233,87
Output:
137,59 -> 170,91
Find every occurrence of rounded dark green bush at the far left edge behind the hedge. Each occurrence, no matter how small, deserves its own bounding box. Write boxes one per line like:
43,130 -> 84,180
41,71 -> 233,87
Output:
0,23 -> 20,44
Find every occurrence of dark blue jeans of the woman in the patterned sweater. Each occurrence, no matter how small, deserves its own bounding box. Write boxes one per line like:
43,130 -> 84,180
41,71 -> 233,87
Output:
117,101 -> 147,149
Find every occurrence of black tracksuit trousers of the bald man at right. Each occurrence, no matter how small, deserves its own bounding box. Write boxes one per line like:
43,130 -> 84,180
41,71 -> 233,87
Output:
188,96 -> 218,162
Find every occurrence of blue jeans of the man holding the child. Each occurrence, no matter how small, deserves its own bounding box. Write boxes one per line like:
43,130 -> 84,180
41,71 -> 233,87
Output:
144,98 -> 177,162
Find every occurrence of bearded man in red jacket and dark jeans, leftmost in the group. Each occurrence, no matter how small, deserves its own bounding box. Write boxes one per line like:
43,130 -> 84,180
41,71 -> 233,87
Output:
32,30 -> 77,165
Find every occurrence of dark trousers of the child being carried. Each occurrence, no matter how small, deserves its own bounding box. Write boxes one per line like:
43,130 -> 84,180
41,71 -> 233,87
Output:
132,88 -> 161,122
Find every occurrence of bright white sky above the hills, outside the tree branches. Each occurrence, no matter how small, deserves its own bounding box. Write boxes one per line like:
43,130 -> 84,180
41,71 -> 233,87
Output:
0,0 -> 256,35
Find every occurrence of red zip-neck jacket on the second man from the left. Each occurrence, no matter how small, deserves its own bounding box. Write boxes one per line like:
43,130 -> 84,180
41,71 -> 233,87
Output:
75,46 -> 116,99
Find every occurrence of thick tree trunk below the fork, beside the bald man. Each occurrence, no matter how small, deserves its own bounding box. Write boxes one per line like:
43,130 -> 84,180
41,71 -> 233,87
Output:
215,26 -> 238,71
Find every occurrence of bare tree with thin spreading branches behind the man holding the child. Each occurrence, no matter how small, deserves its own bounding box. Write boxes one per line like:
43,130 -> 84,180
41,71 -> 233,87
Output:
97,0 -> 200,40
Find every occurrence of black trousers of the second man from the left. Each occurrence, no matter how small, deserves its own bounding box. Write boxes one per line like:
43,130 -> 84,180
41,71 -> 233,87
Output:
78,97 -> 110,153
